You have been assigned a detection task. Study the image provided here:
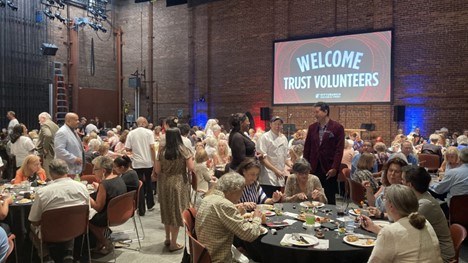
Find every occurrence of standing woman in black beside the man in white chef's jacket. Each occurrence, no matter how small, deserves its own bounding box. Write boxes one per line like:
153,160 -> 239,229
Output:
229,113 -> 255,171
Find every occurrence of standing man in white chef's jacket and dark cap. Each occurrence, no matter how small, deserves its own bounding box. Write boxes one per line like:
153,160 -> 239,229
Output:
256,116 -> 292,198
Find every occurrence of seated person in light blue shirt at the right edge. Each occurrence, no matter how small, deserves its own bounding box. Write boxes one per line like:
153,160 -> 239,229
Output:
430,147 -> 468,205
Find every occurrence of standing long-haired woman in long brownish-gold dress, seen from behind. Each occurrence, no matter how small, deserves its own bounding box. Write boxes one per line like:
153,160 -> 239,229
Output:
155,128 -> 194,252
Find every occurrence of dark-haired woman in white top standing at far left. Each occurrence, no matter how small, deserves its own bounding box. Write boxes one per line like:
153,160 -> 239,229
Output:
10,124 -> 36,168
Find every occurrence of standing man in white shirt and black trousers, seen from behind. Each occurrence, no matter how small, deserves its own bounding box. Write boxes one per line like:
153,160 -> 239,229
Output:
125,117 -> 155,216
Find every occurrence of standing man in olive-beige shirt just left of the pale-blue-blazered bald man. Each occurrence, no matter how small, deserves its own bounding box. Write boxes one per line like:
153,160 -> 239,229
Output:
36,112 -> 59,179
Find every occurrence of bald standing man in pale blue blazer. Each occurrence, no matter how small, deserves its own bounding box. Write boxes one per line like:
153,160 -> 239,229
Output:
54,112 -> 84,175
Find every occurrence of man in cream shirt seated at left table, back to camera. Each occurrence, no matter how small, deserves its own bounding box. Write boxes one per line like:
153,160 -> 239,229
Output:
29,159 -> 89,262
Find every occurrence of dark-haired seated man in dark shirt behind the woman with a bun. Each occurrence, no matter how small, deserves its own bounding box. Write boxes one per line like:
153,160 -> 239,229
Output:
402,165 -> 455,262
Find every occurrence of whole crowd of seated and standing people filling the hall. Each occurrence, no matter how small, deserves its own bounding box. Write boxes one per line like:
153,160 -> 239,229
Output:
0,105 -> 468,262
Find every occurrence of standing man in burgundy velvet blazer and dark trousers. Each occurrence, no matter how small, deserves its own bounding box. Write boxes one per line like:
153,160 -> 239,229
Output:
304,102 -> 344,205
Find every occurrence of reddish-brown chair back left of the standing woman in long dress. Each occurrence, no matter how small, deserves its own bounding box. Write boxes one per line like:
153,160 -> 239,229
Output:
107,190 -> 136,226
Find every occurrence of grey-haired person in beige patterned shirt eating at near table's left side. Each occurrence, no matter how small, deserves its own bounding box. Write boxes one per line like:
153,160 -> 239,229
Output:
195,172 -> 262,263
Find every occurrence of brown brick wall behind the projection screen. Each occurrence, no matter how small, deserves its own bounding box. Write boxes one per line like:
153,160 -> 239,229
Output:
114,0 -> 468,142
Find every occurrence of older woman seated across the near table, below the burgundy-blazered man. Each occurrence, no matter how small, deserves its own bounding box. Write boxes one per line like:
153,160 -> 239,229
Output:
283,158 -> 327,203
